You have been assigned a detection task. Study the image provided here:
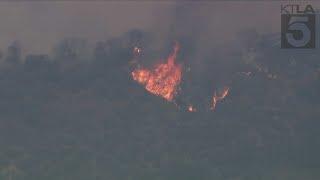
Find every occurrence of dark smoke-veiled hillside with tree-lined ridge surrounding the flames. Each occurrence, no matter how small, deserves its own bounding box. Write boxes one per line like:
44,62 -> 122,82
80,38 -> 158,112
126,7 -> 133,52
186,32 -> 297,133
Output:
0,30 -> 320,180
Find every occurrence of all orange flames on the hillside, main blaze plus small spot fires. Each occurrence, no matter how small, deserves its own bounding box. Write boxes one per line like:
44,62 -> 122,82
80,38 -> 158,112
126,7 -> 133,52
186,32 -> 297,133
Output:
131,42 -> 229,112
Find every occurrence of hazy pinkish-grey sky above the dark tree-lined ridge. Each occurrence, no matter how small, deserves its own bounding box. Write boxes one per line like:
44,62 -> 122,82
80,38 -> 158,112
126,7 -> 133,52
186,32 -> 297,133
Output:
0,1 -> 316,53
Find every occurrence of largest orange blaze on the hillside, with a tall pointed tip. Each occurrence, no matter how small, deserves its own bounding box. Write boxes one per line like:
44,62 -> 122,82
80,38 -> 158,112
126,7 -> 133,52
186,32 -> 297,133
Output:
131,43 -> 182,101
